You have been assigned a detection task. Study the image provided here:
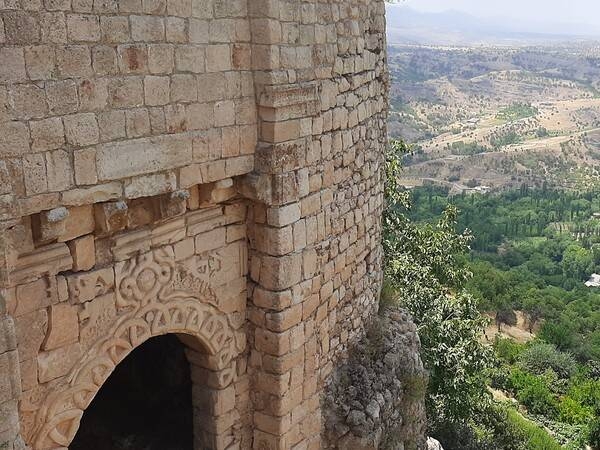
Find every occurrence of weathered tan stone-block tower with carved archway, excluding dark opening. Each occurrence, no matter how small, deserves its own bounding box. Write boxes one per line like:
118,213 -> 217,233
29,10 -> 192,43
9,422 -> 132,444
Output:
0,0 -> 387,450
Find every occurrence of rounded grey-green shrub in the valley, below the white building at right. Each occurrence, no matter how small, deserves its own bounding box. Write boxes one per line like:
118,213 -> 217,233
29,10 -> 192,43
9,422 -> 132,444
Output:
518,342 -> 577,379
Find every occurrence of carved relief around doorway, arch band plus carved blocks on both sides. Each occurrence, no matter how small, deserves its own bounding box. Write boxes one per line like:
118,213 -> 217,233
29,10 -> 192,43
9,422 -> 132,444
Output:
15,223 -> 246,450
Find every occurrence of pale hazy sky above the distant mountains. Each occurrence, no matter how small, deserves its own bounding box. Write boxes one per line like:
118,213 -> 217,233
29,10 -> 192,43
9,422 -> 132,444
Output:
400,0 -> 600,26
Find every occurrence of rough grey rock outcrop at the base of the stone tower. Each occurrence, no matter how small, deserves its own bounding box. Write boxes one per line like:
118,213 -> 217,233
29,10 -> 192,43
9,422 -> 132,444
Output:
323,310 -> 427,450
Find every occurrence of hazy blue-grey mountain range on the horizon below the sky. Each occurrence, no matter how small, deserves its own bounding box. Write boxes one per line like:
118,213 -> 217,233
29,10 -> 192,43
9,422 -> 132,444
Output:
387,5 -> 600,45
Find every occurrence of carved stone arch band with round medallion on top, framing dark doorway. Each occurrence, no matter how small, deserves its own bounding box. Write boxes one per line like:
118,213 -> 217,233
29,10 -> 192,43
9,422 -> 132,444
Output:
29,249 -> 245,449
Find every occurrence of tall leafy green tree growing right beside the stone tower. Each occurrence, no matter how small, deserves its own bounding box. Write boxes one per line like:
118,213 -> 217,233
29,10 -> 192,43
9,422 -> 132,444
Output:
383,142 -> 492,429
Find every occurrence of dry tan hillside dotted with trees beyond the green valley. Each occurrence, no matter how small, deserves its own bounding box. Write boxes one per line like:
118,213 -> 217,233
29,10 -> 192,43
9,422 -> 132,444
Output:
390,45 -> 600,189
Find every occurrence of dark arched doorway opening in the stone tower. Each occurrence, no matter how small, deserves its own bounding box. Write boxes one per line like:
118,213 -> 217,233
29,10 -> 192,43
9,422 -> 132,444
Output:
69,335 -> 193,450
